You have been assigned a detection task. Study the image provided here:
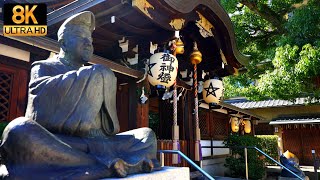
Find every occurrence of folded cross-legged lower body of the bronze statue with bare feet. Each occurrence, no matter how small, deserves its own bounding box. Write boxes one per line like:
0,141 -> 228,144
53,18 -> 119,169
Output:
1,117 -> 159,179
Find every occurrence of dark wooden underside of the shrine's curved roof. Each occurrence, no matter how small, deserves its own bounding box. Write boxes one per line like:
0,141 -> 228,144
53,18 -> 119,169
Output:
0,0 -> 249,77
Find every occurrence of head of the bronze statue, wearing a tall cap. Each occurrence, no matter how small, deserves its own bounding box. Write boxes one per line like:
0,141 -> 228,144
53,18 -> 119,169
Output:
57,11 -> 95,64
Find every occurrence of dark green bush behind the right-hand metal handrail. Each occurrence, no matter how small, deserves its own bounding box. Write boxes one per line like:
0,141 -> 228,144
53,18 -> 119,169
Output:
224,134 -> 265,179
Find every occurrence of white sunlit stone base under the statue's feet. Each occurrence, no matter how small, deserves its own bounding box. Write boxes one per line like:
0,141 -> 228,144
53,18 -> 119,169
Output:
102,166 -> 190,180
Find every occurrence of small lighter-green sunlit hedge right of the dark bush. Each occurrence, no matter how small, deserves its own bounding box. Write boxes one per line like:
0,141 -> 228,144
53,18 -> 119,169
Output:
256,135 -> 279,165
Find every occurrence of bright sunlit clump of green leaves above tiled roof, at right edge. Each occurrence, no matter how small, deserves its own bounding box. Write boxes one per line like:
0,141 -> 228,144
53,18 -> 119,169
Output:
256,44 -> 320,99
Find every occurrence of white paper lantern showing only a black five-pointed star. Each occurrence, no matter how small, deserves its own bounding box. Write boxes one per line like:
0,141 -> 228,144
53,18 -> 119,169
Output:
202,79 -> 223,104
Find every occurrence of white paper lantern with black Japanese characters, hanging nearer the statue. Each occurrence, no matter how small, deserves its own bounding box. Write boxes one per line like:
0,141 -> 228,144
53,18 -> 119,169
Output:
148,52 -> 178,88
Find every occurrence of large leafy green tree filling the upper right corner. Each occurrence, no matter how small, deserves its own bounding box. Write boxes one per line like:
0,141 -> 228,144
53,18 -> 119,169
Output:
220,0 -> 320,100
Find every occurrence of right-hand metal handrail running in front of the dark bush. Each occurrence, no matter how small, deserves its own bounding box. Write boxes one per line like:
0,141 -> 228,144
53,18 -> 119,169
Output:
202,146 -> 304,180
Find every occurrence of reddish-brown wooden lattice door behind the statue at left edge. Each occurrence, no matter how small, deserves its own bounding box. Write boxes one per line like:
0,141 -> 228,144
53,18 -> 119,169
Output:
0,63 -> 28,122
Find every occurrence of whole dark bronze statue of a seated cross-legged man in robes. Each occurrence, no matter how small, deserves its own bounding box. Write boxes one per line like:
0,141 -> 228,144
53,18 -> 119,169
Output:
0,11 -> 160,179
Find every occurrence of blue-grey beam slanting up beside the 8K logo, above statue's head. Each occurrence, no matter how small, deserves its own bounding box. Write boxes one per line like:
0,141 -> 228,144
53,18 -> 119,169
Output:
47,0 -> 105,26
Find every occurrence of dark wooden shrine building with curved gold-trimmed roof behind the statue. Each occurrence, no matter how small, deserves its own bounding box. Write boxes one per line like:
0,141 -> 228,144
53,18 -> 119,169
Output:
0,0 -> 260,174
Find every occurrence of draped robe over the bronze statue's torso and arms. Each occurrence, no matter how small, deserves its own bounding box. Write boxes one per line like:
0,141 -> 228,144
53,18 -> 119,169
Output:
26,60 -> 120,137
